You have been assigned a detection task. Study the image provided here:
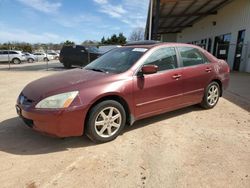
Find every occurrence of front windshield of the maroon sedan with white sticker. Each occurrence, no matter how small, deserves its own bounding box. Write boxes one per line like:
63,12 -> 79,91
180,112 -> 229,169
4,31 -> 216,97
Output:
85,47 -> 148,73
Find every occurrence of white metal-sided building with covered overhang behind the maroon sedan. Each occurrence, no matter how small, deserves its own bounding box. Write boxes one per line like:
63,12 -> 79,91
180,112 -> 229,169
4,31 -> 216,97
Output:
146,0 -> 250,72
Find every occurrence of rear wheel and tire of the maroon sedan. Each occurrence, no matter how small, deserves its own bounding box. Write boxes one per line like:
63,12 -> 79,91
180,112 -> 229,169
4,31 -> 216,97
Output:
201,82 -> 221,109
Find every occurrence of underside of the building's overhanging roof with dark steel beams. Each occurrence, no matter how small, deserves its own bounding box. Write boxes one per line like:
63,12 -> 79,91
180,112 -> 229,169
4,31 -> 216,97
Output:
145,0 -> 233,39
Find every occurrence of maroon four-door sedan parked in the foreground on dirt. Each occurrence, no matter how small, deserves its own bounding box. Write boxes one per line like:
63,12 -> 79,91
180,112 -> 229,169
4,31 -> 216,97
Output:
16,43 -> 230,142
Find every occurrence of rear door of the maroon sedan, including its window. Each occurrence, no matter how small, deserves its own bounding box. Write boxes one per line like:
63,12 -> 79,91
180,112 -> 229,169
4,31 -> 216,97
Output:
177,46 -> 213,105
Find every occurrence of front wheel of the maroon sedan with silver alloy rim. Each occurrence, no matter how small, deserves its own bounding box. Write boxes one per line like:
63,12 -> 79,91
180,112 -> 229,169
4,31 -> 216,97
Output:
85,100 -> 126,143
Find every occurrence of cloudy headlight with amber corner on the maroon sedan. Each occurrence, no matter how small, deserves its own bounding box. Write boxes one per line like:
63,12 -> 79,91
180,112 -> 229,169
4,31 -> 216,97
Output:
36,91 -> 79,108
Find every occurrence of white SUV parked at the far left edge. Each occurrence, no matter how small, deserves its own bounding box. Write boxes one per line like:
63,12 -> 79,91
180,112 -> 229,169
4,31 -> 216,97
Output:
0,50 -> 26,64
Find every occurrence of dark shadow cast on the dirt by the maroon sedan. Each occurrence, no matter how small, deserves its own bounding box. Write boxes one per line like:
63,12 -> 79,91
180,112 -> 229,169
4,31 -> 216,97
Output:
0,106 -> 202,155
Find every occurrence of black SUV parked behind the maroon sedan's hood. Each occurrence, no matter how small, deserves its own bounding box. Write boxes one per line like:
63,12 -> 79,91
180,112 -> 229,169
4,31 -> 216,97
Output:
59,45 -> 101,68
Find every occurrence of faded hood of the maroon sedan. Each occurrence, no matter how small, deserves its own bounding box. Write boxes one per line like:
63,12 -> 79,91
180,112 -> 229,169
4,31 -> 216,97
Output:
22,69 -> 112,101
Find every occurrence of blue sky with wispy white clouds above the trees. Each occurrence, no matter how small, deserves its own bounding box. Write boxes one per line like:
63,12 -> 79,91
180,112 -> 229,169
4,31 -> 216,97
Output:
0,0 -> 149,43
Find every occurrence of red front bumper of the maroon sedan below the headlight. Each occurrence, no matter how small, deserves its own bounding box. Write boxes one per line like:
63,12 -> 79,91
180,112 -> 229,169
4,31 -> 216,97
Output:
16,104 -> 86,137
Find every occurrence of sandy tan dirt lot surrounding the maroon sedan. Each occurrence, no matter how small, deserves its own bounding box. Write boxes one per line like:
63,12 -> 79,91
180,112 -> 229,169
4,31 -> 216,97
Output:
0,63 -> 250,188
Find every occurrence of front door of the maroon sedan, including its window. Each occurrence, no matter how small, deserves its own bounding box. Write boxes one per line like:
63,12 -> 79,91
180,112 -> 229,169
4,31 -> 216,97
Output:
133,47 -> 183,119
